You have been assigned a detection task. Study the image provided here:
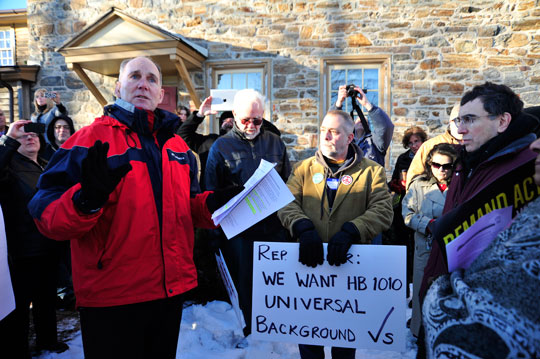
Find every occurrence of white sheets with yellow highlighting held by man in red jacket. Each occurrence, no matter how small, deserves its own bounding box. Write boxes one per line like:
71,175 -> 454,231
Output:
212,160 -> 294,239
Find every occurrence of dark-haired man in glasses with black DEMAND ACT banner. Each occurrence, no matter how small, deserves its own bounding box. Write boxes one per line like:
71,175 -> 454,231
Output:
421,82 -> 539,312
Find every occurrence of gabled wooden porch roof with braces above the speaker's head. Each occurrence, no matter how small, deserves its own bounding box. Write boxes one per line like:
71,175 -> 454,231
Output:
57,8 -> 208,107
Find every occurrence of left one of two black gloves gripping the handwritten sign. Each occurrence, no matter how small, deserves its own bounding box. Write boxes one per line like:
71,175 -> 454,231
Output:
293,218 -> 324,268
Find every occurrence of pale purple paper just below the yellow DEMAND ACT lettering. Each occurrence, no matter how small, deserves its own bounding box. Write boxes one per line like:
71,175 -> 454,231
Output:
446,206 -> 512,272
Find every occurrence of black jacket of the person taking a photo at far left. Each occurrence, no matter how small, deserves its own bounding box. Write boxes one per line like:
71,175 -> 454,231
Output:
0,137 -> 57,258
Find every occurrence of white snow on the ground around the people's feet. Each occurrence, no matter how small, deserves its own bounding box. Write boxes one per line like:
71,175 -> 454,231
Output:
33,301 -> 416,359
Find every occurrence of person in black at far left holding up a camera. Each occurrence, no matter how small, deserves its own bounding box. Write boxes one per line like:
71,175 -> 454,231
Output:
0,120 -> 68,358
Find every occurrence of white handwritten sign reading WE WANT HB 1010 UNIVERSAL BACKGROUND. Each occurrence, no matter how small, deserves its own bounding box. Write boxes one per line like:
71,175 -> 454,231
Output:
252,242 -> 406,351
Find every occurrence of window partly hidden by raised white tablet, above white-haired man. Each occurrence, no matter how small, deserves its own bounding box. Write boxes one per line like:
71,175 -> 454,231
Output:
206,60 -> 271,133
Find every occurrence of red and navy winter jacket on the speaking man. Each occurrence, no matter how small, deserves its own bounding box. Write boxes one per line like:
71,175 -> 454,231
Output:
29,100 -> 215,307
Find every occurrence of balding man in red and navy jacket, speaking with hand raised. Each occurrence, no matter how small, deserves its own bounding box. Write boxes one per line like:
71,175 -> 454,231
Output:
29,57 -> 232,359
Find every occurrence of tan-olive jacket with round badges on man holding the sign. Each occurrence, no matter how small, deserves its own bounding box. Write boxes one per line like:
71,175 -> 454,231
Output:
278,144 -> 393,243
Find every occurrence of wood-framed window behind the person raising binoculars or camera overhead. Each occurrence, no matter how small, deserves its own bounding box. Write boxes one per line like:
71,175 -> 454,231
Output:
321,56 -> 390,120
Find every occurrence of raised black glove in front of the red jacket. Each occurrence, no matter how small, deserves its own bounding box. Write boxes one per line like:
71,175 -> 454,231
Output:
73,140 -> 132,214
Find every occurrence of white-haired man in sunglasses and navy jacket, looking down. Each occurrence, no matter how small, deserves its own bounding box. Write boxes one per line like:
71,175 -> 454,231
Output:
205,89 -> 291,345
